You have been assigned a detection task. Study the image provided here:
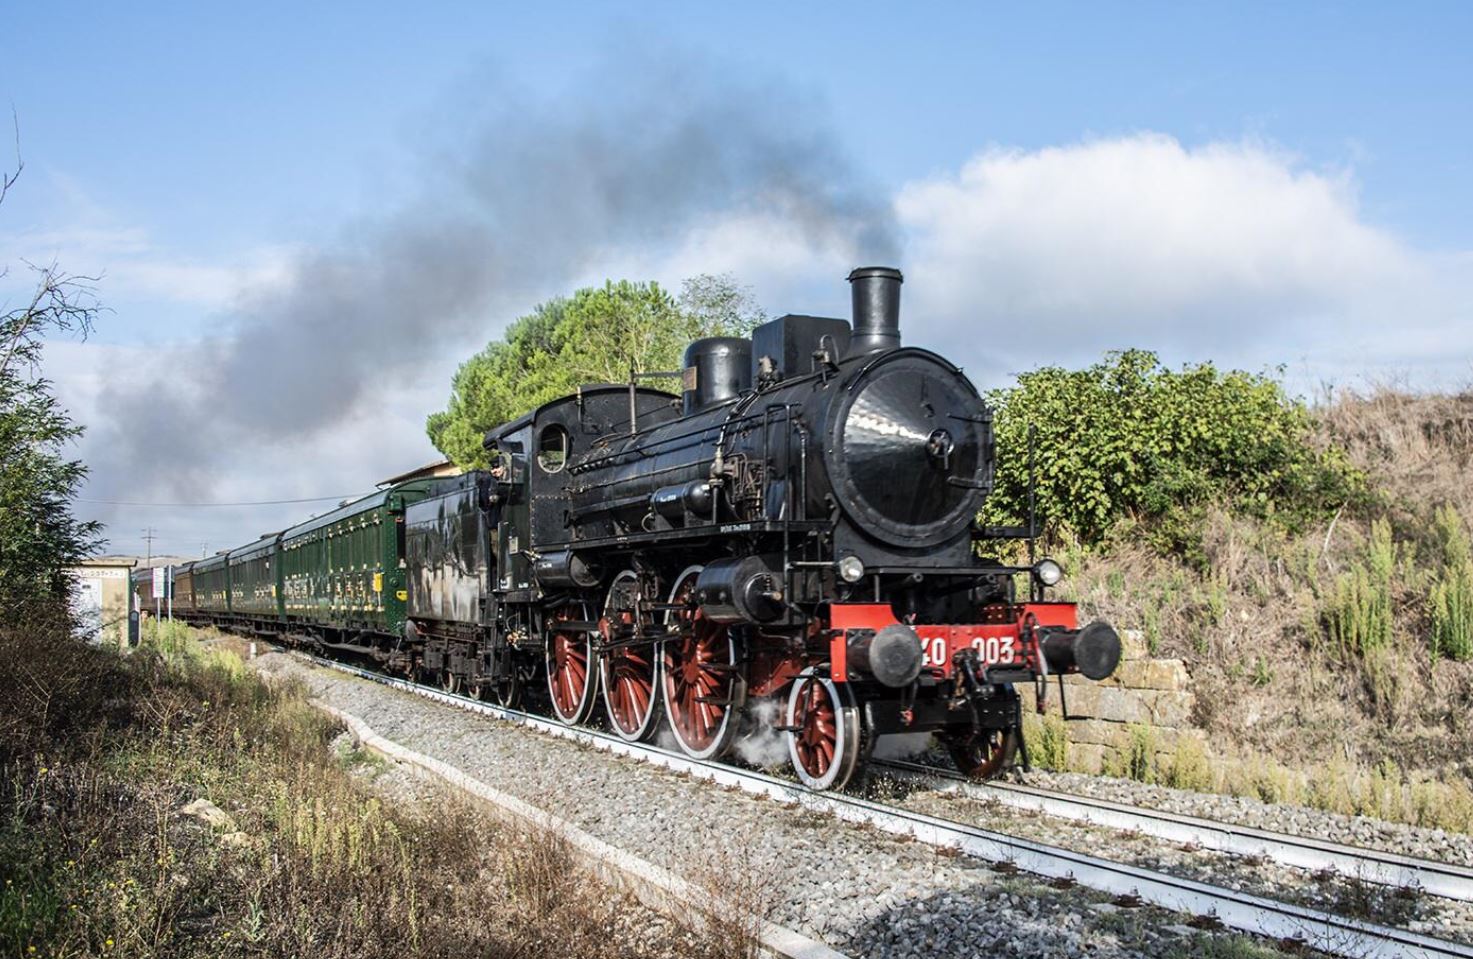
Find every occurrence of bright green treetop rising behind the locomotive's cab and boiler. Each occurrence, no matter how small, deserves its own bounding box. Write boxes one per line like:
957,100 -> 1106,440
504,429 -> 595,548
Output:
426,275 -> 763,467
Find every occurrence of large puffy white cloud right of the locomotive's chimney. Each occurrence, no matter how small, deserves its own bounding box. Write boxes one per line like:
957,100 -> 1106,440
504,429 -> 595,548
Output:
896,134 -> 1473,385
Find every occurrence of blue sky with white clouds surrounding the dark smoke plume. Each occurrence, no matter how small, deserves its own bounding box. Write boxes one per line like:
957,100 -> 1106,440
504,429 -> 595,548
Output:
0,3 -> 1473,548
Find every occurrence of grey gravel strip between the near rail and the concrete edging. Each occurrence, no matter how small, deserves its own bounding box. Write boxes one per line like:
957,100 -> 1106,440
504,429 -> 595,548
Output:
256,654 -> 1302,959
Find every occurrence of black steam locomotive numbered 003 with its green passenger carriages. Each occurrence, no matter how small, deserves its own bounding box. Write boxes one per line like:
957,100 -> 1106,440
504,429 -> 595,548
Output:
167,267 -> 1121,790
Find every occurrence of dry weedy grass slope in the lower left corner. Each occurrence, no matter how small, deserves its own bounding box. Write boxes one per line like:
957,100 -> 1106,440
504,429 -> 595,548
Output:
0,623 -> 753,959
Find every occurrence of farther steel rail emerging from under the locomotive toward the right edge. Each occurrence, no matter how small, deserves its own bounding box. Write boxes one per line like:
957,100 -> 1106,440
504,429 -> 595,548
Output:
873,760 -> 1473,902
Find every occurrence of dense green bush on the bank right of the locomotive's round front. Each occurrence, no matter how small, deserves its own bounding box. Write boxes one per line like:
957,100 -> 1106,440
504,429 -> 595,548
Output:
984,349 -> 1364,553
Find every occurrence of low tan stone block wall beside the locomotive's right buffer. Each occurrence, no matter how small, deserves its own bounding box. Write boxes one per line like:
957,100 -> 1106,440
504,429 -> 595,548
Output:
1018,630 -> 1205,772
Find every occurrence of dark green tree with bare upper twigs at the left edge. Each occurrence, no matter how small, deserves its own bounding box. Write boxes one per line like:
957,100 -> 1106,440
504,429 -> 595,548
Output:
0,161 -> 100,625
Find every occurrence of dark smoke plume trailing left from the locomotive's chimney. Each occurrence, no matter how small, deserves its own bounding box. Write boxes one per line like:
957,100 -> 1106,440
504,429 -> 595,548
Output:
91,50 -> 897,498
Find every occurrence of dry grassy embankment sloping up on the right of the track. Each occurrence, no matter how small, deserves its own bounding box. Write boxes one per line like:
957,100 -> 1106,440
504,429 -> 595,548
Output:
1031,390 -> 1473,831
